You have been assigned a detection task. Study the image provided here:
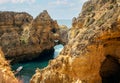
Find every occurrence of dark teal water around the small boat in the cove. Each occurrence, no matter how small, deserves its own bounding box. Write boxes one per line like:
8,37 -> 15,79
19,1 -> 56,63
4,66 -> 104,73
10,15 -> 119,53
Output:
12,60 -> 49,83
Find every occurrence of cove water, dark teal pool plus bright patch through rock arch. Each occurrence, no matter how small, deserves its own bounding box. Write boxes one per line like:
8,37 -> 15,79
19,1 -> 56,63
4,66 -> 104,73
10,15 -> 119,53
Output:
11,44 -> 63,83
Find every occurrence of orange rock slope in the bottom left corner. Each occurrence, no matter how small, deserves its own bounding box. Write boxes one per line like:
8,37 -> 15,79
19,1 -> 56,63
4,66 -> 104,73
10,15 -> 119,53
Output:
0,50 -> 20,83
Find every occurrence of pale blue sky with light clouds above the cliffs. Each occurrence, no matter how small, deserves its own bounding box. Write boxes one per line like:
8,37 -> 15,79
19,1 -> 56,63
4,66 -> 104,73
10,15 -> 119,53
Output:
0,0 -> 87,19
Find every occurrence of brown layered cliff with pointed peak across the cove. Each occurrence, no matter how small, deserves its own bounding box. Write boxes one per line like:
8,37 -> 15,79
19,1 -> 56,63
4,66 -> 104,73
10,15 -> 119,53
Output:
0,10 -> 58,62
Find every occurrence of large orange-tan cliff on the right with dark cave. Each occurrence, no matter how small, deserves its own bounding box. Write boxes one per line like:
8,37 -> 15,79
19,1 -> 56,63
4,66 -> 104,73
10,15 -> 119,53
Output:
31,0 -> 120,83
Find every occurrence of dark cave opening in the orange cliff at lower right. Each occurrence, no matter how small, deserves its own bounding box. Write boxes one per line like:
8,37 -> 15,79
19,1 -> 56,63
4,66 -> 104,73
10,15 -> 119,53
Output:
100,55 -> 120,83
